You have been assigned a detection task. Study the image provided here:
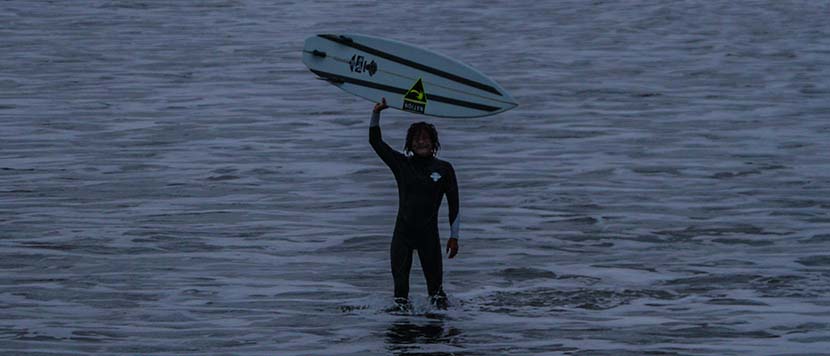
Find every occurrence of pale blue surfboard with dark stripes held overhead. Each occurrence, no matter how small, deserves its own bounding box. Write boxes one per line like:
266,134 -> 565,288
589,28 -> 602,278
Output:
303,34 -> 518,118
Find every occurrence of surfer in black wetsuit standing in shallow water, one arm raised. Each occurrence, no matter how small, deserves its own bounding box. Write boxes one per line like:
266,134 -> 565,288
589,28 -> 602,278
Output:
369,98 -> 459,311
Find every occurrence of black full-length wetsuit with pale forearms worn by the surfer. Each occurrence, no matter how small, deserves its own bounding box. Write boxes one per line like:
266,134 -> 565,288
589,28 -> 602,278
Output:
369,114 -> 459,299
